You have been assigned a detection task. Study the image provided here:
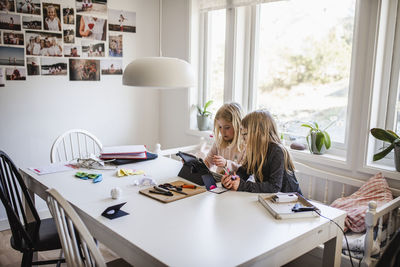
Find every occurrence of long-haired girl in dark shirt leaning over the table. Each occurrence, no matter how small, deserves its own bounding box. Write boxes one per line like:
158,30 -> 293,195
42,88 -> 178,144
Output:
221,110 -> 301,194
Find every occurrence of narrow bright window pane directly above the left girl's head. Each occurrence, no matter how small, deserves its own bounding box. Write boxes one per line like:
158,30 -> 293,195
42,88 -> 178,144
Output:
207,9 -> 226,110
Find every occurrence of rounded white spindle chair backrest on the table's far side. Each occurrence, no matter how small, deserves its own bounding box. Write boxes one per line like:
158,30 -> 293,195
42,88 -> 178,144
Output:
50,129 -> 103,163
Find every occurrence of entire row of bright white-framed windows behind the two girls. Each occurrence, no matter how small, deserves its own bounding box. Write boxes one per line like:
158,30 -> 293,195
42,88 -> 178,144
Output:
199,0 -> 400,178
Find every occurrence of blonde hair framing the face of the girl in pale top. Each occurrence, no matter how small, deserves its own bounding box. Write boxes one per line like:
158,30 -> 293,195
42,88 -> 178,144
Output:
214,102 -> 242,151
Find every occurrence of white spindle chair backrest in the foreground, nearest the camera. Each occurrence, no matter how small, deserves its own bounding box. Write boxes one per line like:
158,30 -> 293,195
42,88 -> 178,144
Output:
47,188 -> 106,267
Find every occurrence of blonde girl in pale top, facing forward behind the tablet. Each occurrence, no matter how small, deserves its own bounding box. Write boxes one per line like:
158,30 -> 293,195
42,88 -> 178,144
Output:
204,103 -> 244,173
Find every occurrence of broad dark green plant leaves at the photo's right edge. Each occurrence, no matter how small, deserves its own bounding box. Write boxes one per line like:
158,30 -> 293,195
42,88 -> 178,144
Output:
371,128 -> 400,172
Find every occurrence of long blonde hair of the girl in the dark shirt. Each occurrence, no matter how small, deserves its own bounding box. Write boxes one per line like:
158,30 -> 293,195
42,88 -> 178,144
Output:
242,109 -> 294,181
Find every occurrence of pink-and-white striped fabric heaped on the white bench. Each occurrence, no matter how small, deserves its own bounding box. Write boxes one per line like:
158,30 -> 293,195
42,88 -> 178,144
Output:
331,173 -> 393,233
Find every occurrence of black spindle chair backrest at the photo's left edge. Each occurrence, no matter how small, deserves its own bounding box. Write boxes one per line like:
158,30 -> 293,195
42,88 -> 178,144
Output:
0,150 -> 40,250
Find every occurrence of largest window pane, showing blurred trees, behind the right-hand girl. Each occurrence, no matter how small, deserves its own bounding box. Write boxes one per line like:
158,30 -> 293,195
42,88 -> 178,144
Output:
257,0 -> 355,143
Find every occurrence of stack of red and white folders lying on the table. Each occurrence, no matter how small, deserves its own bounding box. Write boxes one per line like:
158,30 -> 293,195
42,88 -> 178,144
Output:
100,145 -> 147,159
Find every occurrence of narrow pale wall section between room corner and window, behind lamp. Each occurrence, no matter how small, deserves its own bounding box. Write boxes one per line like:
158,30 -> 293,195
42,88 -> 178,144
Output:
160,0 -> 199,148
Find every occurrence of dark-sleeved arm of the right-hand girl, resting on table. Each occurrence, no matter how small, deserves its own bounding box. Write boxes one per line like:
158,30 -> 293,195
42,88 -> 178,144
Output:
238,145 -> 285,193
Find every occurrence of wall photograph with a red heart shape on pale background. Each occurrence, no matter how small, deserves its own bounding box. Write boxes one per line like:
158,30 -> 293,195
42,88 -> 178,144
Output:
76,15 -> 107,41
